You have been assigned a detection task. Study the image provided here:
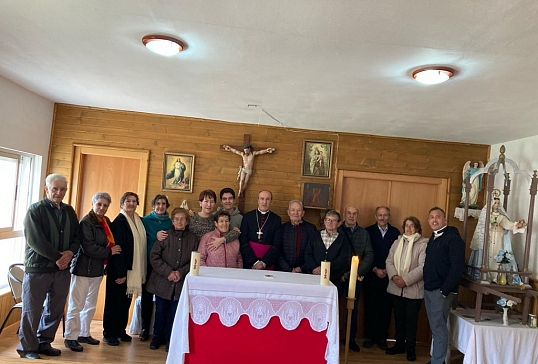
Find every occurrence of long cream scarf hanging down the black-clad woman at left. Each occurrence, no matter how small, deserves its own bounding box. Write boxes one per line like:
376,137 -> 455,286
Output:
120,209 -> 147,297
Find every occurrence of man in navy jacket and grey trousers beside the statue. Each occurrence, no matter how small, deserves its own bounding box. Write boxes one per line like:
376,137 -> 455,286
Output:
424,207 -> 465,364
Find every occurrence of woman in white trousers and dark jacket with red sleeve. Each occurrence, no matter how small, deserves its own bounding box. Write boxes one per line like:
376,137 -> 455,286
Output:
64,192 -> 121,351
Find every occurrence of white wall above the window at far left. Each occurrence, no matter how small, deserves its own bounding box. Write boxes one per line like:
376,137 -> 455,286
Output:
0,76 -> 54,181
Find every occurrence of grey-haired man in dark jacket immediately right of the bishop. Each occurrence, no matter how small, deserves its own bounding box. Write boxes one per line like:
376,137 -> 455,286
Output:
277,200 -> 317,273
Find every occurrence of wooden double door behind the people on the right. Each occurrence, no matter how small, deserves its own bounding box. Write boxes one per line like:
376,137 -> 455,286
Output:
334,171 -> 449,342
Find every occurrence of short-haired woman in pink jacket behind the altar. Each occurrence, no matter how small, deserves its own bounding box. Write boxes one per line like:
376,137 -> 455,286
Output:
198,210 -> 243,268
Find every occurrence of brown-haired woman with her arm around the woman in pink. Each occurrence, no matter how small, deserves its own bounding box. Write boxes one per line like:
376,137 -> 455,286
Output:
189,190 -> 239,250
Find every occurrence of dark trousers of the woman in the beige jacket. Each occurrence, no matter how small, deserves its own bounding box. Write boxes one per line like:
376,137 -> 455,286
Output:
390,294 -> 422,350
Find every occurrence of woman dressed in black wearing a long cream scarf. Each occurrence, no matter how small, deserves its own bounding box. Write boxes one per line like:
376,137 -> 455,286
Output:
103,192 -> 146,346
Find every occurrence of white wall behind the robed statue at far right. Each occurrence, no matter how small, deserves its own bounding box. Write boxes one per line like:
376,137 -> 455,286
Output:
490,139 -> 538,278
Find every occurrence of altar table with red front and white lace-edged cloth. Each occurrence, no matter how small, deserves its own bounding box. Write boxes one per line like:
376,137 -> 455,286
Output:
166,267 -> 339,364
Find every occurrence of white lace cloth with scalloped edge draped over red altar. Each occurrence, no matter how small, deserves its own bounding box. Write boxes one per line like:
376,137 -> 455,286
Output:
166,267 -> 339,364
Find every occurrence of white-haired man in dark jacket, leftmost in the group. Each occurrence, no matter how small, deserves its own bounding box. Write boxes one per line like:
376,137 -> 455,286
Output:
17,174 -> 80,359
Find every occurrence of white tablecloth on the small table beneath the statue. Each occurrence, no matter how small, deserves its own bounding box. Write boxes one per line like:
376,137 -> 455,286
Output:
450,311 -> 538,364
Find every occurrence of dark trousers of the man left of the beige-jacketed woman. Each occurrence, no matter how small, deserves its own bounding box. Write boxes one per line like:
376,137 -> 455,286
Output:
362,272 -> 392,343
